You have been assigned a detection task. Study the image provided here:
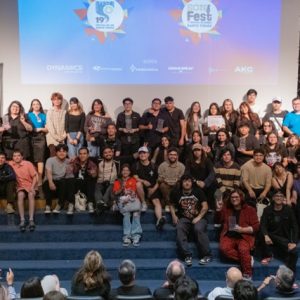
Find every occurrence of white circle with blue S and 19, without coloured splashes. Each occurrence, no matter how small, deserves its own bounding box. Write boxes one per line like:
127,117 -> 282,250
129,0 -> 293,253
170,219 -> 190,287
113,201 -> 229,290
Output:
87,0 -> 124,32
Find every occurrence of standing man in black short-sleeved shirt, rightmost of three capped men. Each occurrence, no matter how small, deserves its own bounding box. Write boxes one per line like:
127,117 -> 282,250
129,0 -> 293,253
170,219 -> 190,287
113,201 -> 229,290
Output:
162,96 -> 186,147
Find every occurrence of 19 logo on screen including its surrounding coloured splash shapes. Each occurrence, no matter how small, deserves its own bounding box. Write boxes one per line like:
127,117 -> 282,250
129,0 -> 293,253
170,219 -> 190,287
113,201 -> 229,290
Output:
74,0 -> 128,44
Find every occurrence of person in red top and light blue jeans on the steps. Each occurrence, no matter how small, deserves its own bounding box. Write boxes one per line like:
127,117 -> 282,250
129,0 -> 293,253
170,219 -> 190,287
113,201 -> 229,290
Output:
113,164 -> 143,247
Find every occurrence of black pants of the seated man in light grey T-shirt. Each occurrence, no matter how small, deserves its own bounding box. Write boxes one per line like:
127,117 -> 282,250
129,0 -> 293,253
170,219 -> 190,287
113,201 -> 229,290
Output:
43,178 -> 76,207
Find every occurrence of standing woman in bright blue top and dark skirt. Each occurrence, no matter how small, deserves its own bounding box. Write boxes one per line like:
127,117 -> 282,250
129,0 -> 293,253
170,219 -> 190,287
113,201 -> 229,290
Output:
28,99 -> 48,187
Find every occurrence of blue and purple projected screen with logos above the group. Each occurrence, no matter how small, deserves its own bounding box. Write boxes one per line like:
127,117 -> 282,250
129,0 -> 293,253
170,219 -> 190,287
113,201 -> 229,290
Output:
18,0 -> 281,85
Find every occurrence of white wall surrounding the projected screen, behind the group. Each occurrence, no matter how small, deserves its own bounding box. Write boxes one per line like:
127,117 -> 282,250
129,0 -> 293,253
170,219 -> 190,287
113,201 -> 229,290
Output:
0,0 -> 300,117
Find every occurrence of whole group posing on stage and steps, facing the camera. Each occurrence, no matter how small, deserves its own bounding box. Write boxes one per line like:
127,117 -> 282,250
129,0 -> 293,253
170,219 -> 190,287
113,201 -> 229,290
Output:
0,89 -> 300,278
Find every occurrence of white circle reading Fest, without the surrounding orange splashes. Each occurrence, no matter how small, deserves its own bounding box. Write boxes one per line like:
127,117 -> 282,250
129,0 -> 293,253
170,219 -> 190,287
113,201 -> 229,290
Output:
181,0 -> 219,33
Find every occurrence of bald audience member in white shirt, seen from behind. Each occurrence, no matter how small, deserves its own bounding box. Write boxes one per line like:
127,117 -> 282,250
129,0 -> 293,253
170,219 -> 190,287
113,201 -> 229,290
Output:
207,267 -> 243,300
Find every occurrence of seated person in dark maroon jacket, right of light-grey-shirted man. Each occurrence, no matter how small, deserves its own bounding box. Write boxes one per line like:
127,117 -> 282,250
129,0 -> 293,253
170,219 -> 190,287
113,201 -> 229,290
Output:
73,147 -> 98,213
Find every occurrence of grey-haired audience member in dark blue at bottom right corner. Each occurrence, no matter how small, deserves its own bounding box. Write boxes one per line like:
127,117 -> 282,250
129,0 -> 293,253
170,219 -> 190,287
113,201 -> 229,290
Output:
257,266 -> 300,299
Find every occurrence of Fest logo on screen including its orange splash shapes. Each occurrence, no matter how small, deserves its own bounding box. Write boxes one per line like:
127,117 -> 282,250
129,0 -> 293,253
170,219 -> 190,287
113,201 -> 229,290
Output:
170,0 -> 222,44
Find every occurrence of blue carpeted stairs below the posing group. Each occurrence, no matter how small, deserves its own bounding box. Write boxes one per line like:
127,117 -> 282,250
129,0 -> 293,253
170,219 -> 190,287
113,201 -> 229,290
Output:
0,210 -> 300,293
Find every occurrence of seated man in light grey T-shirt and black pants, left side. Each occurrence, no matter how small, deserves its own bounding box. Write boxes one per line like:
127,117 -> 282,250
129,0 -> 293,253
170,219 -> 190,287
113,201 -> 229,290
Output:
43,144 -> 76,214
